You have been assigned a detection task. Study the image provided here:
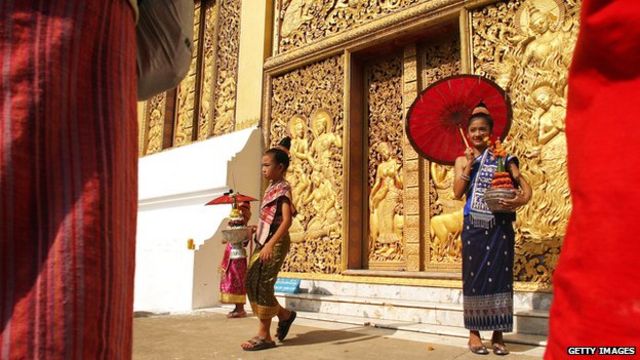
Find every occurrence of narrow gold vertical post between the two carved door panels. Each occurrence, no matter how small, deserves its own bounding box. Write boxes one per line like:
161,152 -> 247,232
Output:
402,44 -> 421,271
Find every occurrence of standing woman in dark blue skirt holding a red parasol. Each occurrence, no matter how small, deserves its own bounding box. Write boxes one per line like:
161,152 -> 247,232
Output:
407,75 -> 532,355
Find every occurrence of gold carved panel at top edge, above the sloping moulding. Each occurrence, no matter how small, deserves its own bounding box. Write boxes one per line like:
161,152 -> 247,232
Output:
277,0 -> 447,53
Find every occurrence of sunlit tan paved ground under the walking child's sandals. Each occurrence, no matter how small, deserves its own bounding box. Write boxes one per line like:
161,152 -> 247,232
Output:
133,309 -> 543,360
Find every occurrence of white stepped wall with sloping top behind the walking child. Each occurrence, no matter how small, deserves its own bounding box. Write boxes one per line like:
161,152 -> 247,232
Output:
134,128 -> 262,312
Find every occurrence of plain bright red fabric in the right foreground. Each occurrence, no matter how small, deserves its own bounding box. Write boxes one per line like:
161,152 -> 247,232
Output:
545,0 -> 640,360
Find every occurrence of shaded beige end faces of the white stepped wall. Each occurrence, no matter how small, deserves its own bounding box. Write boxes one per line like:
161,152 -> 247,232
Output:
192,128 -> 262,309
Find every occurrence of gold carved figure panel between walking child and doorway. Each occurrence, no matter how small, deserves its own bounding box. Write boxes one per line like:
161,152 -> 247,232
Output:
268,56 -> 344,274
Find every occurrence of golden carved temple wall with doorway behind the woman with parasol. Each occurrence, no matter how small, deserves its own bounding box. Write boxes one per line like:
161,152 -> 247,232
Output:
263,0 -> 580,289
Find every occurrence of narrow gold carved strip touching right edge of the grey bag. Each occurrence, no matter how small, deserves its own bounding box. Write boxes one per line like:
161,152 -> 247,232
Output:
173,3 -> 201,146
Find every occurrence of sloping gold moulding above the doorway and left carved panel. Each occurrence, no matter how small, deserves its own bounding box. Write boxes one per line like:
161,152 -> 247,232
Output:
264,0 -> 465,73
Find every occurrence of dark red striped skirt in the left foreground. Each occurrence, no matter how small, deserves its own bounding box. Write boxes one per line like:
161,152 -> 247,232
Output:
0,0 -> 138,360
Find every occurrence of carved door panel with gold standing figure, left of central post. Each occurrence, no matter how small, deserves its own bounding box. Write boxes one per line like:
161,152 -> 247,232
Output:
366,54 -> 404,266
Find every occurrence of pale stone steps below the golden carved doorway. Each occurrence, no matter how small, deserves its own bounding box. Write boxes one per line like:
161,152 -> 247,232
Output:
276,280 -> 550,338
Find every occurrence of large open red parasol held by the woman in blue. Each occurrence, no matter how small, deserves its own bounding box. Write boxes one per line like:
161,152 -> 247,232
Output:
406,75 -> 511,165
